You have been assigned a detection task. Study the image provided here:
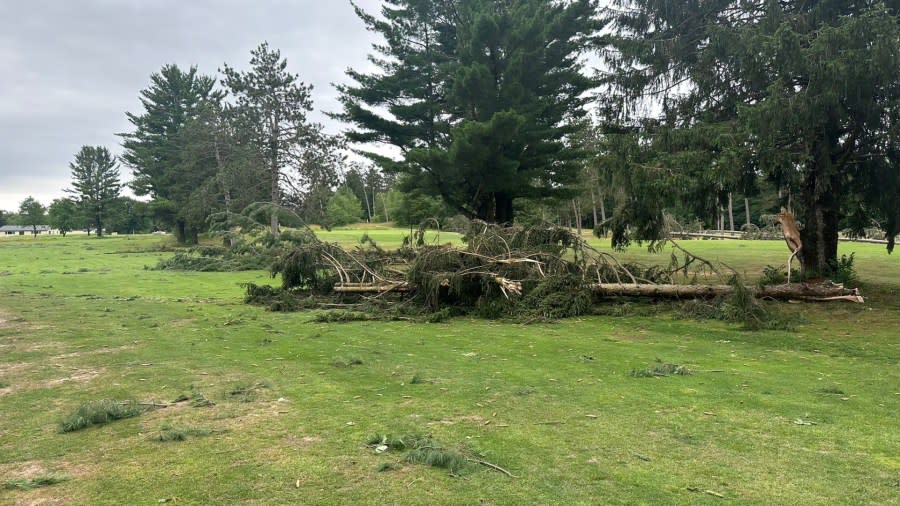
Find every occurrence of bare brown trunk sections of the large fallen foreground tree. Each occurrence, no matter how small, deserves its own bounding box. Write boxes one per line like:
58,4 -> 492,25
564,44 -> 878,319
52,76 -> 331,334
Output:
334,278 -> 865,303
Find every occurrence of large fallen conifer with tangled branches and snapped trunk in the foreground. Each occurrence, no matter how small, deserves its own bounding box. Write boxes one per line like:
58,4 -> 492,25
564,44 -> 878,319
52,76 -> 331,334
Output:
241,222 -> 863,321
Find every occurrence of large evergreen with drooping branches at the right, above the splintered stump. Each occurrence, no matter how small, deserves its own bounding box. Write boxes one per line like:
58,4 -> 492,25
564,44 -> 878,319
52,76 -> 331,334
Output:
604,0 -> 900,273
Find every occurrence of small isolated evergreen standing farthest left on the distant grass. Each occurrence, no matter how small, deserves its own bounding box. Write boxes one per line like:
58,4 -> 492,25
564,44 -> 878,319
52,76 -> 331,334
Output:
65,146 -> 121,237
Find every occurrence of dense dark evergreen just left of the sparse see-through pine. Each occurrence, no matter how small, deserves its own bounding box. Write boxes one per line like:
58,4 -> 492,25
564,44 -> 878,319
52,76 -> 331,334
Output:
119,64 -> 220,242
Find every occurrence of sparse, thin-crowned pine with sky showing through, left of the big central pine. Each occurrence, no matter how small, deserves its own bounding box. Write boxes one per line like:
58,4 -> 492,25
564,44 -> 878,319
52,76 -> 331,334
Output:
222,43 -> 333,234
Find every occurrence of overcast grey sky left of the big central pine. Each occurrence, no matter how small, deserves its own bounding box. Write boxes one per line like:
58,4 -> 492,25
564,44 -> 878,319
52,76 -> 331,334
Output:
0,0 -> 380,211
